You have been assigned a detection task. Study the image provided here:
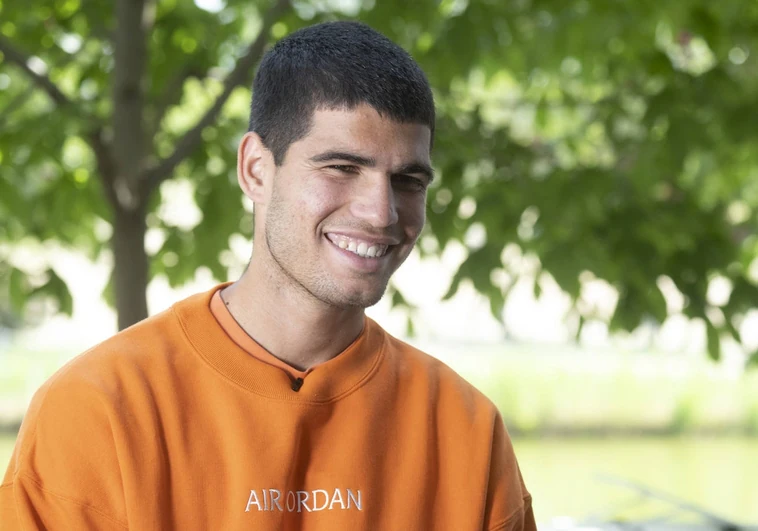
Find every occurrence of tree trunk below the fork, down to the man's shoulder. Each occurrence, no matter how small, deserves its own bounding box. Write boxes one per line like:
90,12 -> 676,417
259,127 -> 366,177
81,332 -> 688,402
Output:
111,208 -> 148,330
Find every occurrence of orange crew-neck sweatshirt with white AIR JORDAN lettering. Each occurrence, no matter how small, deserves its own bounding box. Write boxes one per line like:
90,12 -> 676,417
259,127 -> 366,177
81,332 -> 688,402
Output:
0,288 -> 536,531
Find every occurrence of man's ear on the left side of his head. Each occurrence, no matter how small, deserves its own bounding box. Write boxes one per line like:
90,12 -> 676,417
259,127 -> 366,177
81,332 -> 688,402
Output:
237,132 -> 274,204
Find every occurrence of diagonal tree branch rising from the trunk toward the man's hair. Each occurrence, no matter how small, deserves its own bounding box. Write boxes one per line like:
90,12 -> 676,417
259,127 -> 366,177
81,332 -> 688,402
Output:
145,0 -> 290,195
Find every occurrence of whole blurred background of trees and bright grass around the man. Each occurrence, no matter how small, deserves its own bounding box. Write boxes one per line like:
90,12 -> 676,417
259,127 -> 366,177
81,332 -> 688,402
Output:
0,0 -> 758,529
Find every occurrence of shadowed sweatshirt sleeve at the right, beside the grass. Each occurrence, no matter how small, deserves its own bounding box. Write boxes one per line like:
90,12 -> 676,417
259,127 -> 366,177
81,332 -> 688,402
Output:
484,413 -> 537,531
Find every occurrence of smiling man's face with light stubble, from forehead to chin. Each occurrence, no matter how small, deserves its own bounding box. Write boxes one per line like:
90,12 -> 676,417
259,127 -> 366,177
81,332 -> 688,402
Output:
256,105 -> 431,309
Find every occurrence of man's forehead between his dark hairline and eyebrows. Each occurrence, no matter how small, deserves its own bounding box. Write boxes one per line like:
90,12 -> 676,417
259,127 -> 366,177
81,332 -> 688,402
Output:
289,105 -> 431,164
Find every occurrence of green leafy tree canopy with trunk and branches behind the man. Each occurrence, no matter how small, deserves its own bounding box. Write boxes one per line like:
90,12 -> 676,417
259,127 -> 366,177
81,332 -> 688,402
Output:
0,0 -> 758,359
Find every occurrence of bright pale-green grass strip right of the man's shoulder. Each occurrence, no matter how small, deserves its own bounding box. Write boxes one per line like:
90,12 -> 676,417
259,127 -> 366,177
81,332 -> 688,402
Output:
430,347 -> 758,436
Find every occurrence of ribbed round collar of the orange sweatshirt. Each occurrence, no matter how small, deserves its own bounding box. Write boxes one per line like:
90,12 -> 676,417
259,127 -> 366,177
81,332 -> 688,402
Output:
172,285 -> 386,404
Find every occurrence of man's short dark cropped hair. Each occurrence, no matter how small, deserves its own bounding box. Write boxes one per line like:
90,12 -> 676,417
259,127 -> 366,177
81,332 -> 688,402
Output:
249,21 -> 434,166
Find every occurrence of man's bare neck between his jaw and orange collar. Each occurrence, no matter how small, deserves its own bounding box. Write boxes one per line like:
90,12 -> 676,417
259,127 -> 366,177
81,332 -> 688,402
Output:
222,258 -> 364,370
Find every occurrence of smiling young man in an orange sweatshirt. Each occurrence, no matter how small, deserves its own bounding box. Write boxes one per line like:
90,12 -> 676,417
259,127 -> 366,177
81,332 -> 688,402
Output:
0,22 -> 535,531
